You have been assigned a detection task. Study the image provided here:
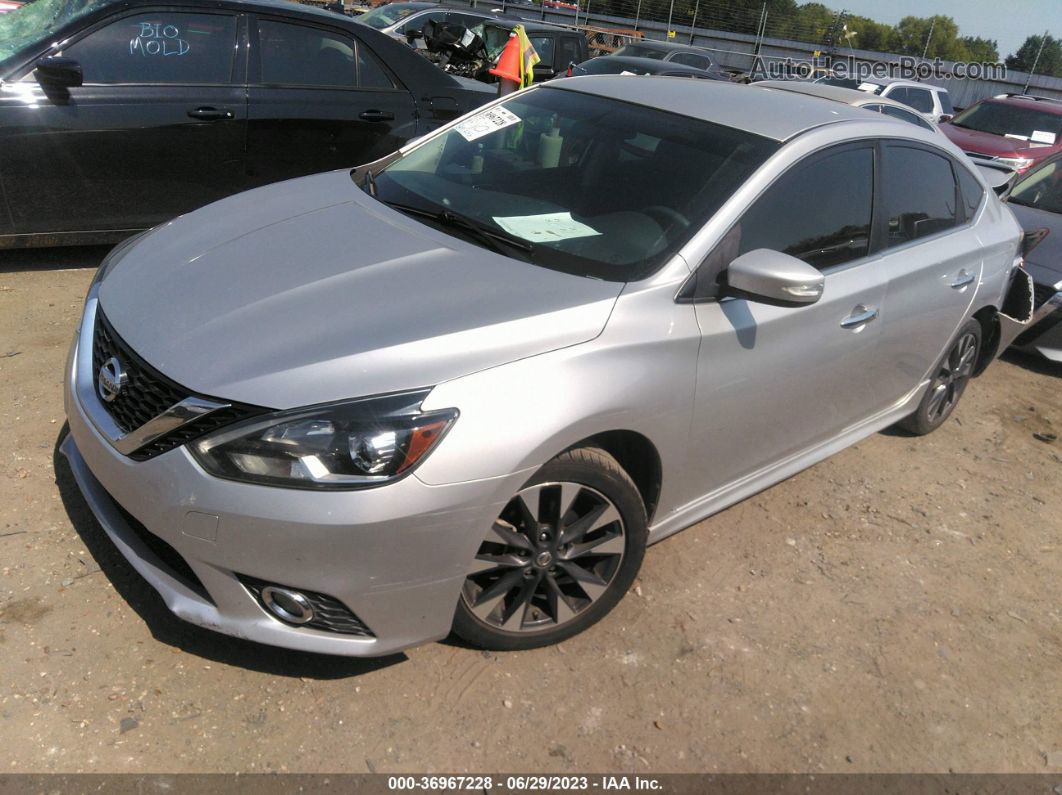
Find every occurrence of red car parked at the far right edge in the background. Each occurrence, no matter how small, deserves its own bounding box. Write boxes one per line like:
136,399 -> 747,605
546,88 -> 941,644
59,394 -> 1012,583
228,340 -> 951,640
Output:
940,93 -> 1062,174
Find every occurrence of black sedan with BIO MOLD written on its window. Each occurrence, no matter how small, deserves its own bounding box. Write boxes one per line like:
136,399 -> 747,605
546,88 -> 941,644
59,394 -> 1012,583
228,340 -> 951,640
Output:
0,0 -> 495,247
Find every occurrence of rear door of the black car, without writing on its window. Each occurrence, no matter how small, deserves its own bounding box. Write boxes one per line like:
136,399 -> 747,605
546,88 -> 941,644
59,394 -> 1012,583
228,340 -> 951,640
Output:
247,17 -> 417,185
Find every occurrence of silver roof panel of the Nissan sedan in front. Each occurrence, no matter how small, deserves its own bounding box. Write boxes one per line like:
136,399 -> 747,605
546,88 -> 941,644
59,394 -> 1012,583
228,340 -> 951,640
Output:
543,74 -> 887,141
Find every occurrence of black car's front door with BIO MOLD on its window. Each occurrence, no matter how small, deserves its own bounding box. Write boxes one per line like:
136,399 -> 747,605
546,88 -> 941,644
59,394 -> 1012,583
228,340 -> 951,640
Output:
0,7 -> 246,234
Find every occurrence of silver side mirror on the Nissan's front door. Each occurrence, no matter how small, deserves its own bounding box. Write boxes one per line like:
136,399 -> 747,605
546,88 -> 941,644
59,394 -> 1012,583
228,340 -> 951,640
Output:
726,248 -> 826,307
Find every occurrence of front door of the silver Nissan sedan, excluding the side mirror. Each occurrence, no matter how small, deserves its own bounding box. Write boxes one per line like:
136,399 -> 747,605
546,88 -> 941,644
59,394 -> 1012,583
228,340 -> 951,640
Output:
690,144 -> 888,494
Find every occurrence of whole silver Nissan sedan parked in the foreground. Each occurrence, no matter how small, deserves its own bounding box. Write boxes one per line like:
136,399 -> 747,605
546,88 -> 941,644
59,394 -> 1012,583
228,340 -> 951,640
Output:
63,75 -> 1028,656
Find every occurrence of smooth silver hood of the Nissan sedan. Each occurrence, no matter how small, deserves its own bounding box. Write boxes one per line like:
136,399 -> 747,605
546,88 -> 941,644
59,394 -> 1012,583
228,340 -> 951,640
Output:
99,171 -> 622,409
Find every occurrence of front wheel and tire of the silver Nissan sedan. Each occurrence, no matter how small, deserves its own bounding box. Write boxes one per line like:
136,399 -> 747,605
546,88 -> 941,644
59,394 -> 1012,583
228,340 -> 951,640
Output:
453,447 -> 649,651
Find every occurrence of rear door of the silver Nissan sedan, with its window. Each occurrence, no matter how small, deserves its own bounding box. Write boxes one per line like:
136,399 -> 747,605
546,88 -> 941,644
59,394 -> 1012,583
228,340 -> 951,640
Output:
879,142 -> 982,400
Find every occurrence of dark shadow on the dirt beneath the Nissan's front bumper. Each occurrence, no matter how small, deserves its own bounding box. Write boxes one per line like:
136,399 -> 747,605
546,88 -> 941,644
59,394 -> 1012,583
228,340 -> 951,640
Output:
52,426 -> 408,679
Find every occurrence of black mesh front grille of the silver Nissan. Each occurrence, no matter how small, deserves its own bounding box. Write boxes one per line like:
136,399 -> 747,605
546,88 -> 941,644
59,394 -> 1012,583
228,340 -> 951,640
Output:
92,309 -> 269,461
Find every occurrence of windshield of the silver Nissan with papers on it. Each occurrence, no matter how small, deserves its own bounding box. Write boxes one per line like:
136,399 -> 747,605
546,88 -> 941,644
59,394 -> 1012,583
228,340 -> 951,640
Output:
370,87 -> 780,281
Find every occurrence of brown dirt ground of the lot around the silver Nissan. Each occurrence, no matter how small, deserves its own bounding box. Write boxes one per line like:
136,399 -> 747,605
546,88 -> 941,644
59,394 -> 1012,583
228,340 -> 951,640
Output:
0,249 -> 1062,773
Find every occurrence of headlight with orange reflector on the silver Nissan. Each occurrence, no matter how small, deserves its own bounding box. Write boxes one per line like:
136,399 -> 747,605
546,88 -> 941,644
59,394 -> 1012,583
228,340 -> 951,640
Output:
191,391 -> 458,489
